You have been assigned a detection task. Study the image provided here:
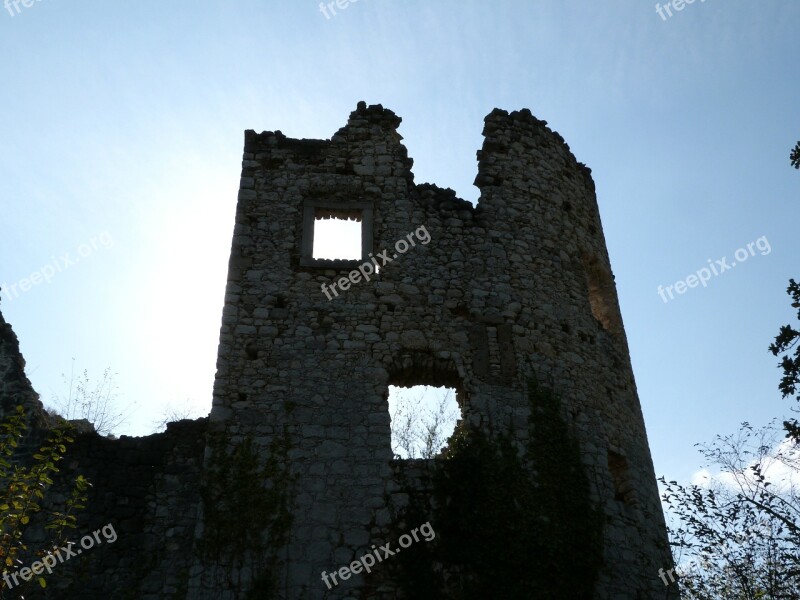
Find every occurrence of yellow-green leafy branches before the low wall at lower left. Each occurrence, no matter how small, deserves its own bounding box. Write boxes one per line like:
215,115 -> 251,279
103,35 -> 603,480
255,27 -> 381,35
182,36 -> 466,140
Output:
0,406 -> 90,598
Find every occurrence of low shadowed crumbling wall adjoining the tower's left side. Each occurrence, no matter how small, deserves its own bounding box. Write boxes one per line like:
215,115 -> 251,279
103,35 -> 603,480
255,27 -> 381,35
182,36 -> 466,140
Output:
0,314 -> 208,600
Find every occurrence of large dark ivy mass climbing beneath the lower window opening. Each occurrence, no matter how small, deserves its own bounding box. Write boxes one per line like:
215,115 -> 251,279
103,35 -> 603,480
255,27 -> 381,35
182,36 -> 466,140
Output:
372,383 -> 603,600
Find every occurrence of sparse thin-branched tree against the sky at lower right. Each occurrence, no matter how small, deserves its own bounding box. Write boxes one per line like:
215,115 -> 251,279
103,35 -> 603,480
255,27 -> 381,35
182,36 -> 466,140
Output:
660,422 -> 800,600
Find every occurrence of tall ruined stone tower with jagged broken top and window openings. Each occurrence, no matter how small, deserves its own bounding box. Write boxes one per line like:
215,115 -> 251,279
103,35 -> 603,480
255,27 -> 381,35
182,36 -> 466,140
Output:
189,102 -> 671,599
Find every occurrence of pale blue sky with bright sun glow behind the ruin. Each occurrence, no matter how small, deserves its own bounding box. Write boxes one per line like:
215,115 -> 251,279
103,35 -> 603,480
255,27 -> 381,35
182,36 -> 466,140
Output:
0,0 -> 800,480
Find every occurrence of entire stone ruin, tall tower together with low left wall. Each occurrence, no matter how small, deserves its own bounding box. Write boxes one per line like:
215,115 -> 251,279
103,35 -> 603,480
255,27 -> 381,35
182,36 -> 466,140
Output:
0,103 -> 671,600
